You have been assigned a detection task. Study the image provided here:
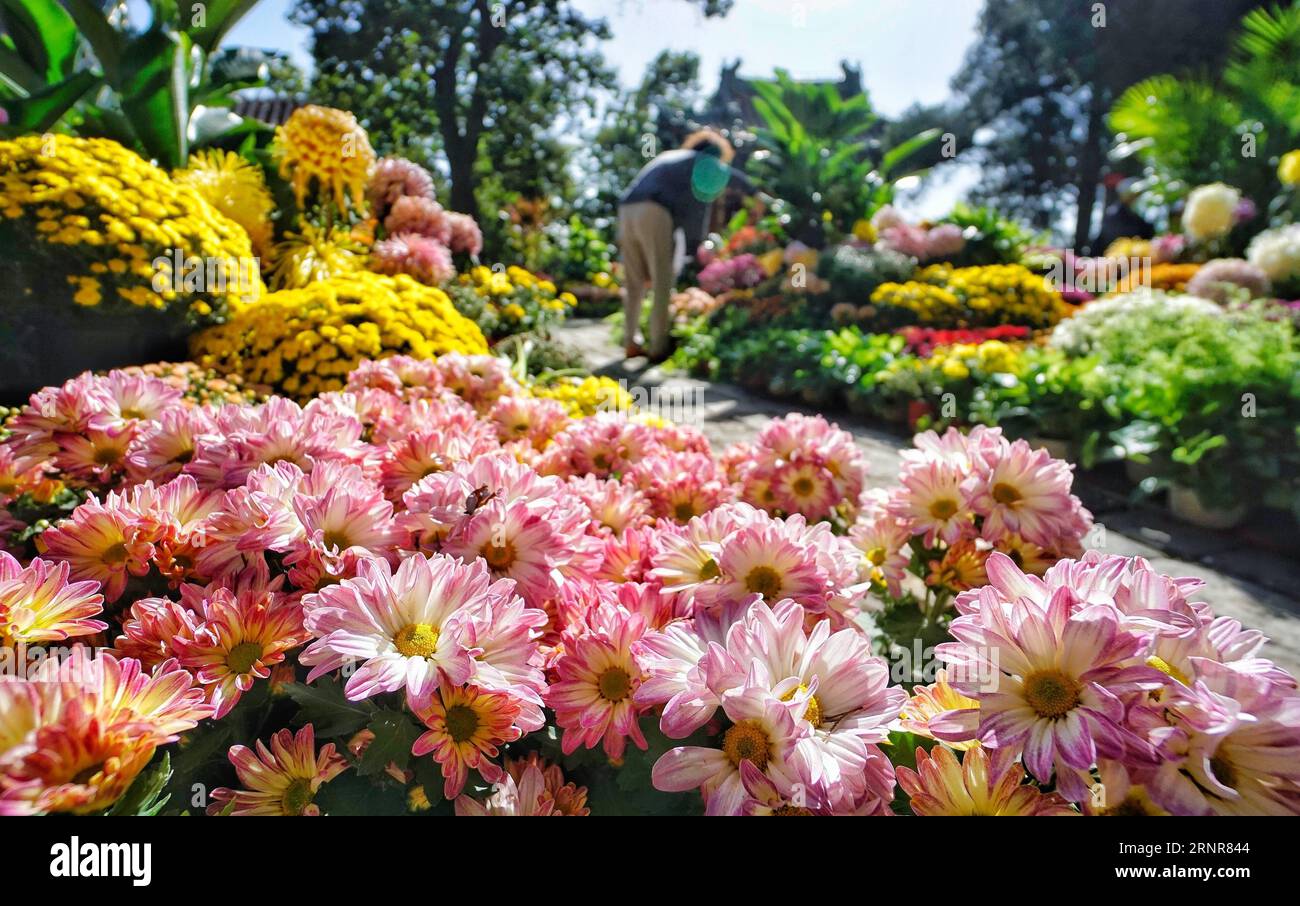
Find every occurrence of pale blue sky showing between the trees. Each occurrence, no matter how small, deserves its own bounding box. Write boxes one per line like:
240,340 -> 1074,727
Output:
229,0 -> 983,217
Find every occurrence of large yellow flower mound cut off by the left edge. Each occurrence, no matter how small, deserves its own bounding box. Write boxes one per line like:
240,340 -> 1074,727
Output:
0,135 -> 263,322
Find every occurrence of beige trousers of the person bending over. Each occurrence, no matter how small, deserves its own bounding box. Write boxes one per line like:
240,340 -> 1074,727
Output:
619,201 -> 675,356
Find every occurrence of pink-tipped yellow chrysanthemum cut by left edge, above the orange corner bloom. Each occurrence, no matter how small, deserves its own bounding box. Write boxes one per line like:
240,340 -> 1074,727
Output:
0,551 -> 108,649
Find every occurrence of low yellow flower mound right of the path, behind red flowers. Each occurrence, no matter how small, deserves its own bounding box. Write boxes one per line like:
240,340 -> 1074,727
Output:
871,264 -> 1070,328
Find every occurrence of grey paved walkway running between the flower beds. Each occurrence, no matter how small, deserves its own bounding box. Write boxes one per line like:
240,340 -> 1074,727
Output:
556,318 -> 1300,675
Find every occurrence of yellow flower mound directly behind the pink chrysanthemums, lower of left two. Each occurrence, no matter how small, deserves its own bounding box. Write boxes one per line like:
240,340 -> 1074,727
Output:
190,270 -> 488,400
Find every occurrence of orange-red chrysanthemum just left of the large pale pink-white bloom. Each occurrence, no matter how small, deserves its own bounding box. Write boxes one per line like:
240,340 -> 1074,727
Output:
172,589 -> 309,719
